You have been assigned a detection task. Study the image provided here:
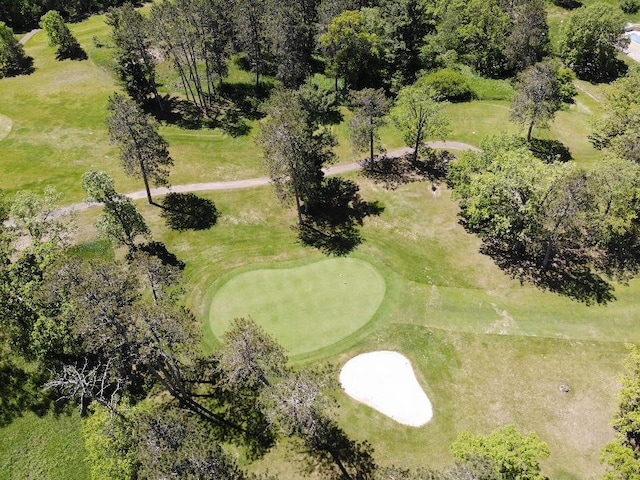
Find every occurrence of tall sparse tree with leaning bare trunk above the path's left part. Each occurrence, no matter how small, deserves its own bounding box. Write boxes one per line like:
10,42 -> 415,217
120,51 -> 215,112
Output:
107,93 -> 173,204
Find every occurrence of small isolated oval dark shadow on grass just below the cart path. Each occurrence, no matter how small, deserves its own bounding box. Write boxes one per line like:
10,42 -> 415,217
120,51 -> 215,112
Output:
160,193 -> 218,232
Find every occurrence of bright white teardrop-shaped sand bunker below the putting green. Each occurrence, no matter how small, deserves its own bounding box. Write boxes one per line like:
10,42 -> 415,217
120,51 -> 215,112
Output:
340,351 -> 433,427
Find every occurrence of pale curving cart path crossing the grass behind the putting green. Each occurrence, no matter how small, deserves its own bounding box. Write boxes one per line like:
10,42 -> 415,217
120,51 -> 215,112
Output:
56,141 -> 480,215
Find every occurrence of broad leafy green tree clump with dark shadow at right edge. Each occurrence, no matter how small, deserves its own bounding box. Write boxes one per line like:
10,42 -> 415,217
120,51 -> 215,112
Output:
449,141 -> 640,303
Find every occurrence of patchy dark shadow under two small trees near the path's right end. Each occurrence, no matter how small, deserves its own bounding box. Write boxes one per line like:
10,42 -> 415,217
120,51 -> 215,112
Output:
362,149 -> 456,190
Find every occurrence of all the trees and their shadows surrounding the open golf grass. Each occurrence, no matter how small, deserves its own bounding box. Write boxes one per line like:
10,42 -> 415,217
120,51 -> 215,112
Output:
0,0 -> 640,480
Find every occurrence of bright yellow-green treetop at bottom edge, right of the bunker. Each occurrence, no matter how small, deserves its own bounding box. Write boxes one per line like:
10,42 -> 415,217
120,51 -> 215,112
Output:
451,425 -> 550,480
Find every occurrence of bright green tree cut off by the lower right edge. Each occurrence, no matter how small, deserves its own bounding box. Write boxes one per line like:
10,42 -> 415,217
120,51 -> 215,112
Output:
600,345 -> 640,480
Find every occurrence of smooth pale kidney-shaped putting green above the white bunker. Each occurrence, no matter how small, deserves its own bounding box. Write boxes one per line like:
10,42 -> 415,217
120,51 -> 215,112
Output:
209,258 -> 386,355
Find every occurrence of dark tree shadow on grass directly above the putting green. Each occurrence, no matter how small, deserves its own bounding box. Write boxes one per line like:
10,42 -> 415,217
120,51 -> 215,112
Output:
296,177 -> 384,256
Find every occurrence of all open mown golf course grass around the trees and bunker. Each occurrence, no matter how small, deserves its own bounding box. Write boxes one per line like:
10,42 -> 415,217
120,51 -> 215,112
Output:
0,9 -> 640,480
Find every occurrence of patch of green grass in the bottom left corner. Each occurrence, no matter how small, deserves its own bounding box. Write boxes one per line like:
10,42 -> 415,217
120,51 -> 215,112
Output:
0,413 -> 89,480
